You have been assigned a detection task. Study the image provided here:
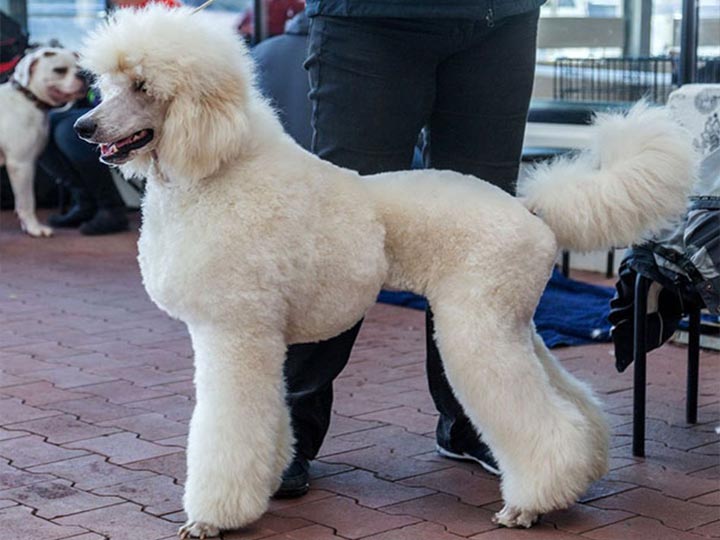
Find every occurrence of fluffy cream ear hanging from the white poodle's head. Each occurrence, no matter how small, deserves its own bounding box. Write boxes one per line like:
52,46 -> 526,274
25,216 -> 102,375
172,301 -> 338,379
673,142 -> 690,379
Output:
158,88 -> 249,179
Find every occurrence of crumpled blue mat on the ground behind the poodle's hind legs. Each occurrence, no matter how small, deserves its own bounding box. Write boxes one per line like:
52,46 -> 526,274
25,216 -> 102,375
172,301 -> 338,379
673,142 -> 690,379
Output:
378,269 -> 615,347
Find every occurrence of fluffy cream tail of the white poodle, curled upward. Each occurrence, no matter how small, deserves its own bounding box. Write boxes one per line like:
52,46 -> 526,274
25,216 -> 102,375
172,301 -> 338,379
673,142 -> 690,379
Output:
518,102 -> 698,251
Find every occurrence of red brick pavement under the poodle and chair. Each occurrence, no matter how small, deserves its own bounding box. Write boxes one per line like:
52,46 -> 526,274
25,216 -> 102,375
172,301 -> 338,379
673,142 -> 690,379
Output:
0,212 -> 720,540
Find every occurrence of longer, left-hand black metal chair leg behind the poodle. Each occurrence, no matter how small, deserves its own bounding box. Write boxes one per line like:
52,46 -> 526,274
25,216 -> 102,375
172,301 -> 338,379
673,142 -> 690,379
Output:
633,274 -> 651,457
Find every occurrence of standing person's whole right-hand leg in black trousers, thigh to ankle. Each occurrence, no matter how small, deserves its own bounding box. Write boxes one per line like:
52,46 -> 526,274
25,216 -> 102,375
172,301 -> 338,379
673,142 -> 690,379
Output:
426,11 -> 538,469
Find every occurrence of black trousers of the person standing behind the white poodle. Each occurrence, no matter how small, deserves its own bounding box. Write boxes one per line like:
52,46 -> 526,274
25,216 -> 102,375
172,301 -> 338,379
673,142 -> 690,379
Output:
285,11 -> 539,459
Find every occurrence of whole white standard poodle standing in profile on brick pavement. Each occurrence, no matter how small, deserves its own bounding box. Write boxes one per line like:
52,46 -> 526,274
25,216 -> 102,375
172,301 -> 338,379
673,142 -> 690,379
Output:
76,6 -> 694,537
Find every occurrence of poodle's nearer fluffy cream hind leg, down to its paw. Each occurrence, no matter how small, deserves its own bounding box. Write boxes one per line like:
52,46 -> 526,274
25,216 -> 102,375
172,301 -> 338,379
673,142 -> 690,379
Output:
431,286 -> 595,526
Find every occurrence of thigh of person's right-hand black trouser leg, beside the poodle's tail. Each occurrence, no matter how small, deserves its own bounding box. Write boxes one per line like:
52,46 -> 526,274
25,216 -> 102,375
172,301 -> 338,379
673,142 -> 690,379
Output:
428,11 -> 539,188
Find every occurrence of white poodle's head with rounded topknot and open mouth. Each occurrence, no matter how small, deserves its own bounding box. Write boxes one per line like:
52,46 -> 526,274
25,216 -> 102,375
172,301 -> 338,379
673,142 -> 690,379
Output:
75,4 -> 253,178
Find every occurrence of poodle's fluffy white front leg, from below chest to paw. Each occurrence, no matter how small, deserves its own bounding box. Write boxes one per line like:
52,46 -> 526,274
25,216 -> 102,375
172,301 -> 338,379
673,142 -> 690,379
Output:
180,328 -> 292,538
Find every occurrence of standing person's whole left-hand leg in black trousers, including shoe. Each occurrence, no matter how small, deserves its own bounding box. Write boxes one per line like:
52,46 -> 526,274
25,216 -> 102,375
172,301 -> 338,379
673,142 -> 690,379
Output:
280,17 -> 442,495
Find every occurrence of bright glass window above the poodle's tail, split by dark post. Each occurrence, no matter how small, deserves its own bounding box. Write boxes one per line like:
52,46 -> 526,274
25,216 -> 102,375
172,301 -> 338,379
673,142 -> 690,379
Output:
534,0 -> 720,103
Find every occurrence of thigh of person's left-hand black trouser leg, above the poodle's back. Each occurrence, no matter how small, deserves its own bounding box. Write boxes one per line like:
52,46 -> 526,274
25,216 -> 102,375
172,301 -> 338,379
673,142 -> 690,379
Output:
305,17 -> 444,175
